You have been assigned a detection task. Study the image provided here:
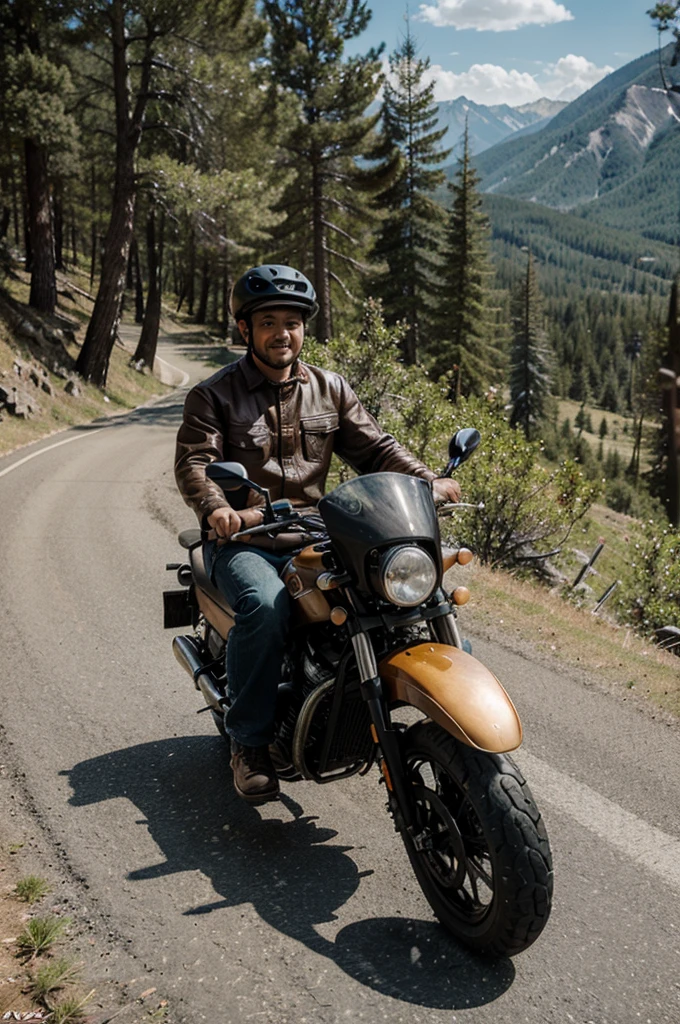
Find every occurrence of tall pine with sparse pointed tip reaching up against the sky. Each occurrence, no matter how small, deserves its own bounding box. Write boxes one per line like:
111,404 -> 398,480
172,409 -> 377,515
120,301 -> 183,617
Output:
372,23 -> 451,362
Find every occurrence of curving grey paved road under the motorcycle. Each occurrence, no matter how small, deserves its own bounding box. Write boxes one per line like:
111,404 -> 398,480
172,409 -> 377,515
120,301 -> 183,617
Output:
0,331 -> 680,1024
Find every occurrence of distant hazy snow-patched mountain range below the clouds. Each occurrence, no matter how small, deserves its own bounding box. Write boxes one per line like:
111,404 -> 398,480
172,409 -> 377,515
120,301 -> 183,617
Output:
437,96 -> 566,156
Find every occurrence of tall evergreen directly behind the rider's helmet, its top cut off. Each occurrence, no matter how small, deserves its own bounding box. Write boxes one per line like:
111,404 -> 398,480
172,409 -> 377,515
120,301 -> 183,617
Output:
263,0 -> 398,341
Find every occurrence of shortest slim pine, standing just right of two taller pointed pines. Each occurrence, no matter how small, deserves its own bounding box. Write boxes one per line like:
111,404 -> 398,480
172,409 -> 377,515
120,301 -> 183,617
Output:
510,250 -> 550,439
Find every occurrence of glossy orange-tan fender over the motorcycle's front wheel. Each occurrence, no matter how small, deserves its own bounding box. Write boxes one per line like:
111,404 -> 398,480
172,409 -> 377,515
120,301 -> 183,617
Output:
378,643 -> 522,754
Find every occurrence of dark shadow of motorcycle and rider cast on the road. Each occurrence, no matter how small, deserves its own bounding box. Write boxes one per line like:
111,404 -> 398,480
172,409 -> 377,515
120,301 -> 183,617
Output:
63,736 -> 515,1010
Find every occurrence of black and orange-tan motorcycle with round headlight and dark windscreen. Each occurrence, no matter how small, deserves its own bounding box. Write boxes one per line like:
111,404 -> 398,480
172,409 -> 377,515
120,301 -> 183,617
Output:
164,428 -> 553,956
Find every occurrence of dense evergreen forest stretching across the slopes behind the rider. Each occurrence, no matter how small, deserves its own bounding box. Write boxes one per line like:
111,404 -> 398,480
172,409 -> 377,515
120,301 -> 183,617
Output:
0,0 -> 677,630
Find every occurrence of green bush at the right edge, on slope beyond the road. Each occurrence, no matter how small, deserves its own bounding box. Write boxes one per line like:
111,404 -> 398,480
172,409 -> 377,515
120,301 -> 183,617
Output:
619,520 -> 680,634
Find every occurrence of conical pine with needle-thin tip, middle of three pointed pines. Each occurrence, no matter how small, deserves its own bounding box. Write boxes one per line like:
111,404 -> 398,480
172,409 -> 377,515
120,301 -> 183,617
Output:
430,125 -> 505,399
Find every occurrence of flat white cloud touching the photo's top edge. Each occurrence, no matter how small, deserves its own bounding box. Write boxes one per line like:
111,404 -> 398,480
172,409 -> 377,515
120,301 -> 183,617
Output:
418,0 -> 573,32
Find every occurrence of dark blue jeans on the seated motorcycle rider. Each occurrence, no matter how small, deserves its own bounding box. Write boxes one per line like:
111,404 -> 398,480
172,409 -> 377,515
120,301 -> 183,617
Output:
204,541 -> 291,746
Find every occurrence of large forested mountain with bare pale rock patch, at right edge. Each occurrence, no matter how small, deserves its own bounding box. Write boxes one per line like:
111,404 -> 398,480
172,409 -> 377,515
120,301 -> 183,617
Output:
464,44 -> 680,244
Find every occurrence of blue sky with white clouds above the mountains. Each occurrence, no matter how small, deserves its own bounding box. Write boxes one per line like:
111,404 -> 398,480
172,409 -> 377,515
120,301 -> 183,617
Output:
348,0 -> 656,105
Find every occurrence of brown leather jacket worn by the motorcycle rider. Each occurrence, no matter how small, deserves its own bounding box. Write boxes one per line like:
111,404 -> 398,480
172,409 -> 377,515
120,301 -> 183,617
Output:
175,355 -> 436,524
